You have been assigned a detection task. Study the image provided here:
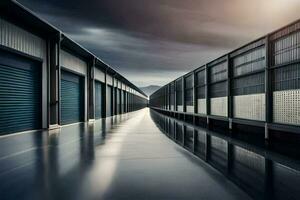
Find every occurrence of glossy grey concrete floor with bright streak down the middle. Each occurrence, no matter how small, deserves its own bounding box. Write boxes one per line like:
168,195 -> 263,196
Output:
0,109 -> 250,200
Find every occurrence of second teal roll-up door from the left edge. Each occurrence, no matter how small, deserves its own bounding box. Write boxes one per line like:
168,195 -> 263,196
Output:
61,71 -> 84,124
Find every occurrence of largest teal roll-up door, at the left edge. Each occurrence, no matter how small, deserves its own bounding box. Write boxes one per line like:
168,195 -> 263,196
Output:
0,51 -> 42,135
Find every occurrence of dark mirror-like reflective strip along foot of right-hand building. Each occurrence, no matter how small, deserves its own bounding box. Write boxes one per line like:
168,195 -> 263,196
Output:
151,111 -> 300,199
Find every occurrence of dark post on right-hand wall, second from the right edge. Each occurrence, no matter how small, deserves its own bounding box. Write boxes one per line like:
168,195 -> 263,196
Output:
227,54 -> 233,131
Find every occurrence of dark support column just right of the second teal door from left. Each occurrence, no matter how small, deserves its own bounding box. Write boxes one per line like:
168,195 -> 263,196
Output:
88,57 -> 96,121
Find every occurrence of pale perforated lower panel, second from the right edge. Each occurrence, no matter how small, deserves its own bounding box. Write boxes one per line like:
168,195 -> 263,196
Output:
233,94 -> 266,121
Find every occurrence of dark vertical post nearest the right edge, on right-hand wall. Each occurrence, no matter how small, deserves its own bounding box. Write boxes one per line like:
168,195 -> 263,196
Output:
265,35 -> 273,140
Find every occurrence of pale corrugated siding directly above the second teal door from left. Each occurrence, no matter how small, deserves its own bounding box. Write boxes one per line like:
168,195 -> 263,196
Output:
60,50 -> 87,75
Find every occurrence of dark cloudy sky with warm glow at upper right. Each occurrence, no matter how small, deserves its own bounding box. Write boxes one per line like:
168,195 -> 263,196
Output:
18,0 -> 300,86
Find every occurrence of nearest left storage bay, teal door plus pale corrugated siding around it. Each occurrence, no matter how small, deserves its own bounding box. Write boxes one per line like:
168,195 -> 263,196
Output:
0,17 -> 47,135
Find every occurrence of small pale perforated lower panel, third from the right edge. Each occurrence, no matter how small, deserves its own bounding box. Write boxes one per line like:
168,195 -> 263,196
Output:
210,97 -> 228,117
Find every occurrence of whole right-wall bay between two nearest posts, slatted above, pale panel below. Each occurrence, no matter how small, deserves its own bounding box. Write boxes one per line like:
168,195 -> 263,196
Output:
231,39 -> 266,121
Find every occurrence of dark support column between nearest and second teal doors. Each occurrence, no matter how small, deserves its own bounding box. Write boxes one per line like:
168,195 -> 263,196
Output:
49,33 -> 61,129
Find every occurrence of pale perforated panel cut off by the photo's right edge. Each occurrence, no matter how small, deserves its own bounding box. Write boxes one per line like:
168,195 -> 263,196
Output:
273,89 -> 300,125
